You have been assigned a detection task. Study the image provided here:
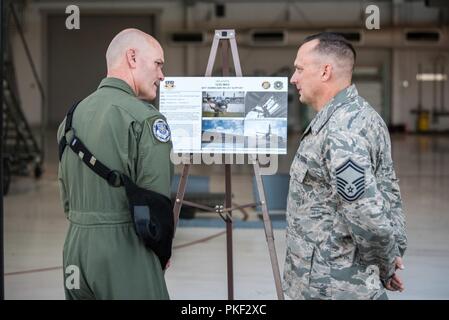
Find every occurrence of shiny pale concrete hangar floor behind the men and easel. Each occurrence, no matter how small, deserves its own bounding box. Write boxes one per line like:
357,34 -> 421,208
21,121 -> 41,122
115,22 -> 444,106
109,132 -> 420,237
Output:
4,136 -> 449,299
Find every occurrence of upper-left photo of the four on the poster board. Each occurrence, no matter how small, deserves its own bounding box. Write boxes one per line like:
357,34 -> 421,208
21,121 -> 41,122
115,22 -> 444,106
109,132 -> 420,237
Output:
202,91 -> 245,118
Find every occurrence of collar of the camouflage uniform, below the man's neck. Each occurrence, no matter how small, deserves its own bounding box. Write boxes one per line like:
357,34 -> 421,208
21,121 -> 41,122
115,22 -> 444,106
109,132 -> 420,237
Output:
310,84 -> 359,135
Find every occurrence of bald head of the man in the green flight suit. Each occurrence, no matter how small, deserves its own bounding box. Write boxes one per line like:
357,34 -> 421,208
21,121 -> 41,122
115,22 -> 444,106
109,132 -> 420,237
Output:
106,29 -> 164,100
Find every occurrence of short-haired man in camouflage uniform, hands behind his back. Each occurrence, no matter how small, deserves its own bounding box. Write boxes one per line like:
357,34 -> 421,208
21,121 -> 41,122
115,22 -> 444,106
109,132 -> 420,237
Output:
283,33 -> 407,299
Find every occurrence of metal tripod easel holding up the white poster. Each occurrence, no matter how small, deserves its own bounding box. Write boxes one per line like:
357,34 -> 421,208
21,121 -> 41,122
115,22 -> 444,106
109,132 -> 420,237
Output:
173,30 -> 284,300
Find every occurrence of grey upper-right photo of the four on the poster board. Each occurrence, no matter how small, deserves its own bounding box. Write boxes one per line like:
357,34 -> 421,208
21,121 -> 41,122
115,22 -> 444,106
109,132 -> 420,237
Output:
245,92 -> 287,119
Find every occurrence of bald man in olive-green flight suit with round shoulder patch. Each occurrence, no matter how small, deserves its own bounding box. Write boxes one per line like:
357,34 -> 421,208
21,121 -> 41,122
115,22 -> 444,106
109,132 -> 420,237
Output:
58,29 -> 173,299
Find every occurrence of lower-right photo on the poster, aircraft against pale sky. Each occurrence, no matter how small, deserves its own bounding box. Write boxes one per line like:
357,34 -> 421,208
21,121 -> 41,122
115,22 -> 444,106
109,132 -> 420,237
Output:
243,119 -> 287,149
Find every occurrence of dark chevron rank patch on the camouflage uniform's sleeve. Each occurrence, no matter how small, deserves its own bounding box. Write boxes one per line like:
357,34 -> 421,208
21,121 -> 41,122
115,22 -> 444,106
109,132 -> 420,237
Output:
336,159 -> 365,202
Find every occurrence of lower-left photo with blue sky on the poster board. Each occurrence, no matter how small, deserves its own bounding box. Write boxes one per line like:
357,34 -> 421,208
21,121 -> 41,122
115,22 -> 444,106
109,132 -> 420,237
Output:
201,119 -> 245,150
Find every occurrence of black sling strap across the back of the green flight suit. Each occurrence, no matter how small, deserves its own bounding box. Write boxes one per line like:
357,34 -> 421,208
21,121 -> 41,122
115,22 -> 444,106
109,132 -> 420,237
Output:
59,102 -> 123,187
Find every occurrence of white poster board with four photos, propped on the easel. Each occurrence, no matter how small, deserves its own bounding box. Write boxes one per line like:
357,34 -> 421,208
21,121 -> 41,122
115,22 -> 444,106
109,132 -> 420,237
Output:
159,77 -> 288,154
